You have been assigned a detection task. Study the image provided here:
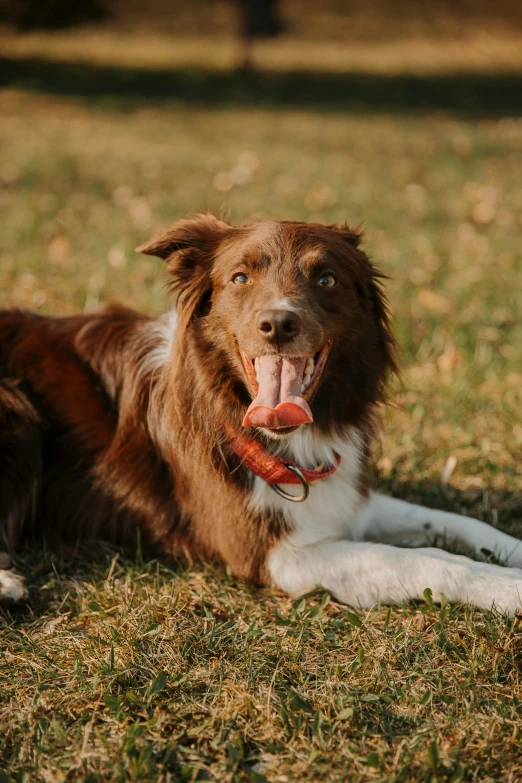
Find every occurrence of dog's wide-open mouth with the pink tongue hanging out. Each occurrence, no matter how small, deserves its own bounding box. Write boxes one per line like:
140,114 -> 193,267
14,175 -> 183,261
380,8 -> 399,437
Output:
240,342 -> 332,432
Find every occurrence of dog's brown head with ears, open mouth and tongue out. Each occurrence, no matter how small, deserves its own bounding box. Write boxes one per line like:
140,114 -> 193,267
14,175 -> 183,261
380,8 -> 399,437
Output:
138,215 -> 395,437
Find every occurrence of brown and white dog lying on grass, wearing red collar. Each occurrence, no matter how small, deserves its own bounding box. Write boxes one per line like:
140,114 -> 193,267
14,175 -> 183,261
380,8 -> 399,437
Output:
0,215 -> 522,612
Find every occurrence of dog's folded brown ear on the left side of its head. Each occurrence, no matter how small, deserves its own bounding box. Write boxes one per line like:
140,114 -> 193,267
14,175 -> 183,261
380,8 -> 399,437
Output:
136,214 -> 230,321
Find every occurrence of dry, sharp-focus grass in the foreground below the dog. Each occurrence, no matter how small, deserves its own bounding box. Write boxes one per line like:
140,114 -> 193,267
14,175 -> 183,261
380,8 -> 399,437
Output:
0,556 -> 522,783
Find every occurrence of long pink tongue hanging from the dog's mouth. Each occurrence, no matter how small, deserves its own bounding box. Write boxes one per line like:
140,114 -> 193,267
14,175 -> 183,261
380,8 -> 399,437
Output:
243,356 -> 313,429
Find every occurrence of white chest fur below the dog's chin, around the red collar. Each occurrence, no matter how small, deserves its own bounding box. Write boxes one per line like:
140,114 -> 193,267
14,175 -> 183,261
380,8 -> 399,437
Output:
251,427 -> 365,546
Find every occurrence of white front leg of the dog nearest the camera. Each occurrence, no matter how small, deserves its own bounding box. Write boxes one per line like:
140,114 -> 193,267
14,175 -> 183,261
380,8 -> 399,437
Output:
267,536 -> 522,614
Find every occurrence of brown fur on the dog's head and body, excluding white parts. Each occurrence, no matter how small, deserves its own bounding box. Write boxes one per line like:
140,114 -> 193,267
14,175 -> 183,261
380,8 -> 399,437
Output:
0,215 -> 395,583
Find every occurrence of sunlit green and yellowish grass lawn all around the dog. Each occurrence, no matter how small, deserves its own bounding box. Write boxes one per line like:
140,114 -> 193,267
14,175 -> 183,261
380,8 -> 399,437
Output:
0,9 -> 522,783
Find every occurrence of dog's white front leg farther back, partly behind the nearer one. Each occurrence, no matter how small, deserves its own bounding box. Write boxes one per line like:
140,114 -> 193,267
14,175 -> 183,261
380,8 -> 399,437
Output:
358,493 -> 522,568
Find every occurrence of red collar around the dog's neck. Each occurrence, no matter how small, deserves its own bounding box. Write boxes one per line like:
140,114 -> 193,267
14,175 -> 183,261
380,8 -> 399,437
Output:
225,435 -> 341,484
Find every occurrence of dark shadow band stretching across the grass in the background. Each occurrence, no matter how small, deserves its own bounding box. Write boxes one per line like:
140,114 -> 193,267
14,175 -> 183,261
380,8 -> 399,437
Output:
0,57 -> 522,117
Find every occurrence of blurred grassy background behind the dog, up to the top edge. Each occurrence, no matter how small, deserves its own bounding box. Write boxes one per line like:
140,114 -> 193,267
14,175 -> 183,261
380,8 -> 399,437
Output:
0,0 -> 522,516
